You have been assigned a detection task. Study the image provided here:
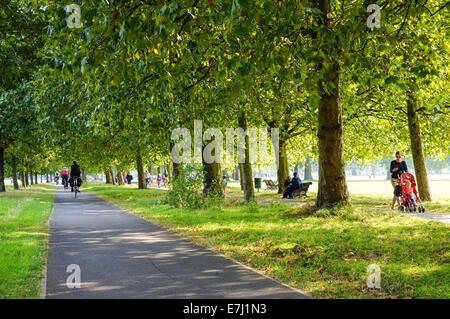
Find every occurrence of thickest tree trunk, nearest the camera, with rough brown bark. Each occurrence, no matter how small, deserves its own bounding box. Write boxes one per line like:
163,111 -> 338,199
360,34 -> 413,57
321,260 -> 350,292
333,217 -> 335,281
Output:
316,0 -> 348,207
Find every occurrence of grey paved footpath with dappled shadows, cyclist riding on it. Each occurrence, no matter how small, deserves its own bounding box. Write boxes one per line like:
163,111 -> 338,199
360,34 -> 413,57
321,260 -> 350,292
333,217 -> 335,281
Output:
46,187 -> 309,299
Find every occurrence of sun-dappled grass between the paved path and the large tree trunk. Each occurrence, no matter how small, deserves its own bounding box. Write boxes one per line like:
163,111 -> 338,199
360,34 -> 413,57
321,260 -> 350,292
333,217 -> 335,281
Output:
85,184 -> 450,298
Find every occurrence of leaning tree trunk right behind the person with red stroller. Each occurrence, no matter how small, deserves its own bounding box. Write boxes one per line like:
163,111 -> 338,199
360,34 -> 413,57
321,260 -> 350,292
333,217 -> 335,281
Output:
407,91 -> 431,201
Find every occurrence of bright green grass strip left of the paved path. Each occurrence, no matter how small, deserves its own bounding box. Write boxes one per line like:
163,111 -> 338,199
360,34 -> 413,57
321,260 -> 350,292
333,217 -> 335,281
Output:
0,185 -> 54,299
